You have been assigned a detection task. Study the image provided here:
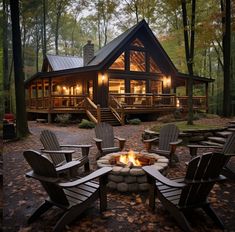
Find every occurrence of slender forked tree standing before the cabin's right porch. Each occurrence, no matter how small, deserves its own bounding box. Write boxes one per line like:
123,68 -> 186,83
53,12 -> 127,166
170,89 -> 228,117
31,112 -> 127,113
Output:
181,0 -> 196,125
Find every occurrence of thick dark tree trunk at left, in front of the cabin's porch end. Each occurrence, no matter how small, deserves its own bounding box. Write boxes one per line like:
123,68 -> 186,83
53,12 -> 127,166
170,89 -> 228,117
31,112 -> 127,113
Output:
10,0 -> 29,138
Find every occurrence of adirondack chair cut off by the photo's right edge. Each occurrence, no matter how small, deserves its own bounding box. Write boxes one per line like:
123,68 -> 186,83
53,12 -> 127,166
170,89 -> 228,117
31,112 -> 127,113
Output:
188,132 -> 235,179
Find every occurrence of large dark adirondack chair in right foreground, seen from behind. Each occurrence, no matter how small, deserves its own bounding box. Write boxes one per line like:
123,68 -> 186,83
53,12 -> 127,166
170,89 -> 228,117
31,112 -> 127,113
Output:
143,153 -> 226,232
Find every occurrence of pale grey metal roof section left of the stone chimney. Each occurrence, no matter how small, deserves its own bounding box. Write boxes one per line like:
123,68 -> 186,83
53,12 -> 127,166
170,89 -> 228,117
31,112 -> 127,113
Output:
46,55 -> 83,71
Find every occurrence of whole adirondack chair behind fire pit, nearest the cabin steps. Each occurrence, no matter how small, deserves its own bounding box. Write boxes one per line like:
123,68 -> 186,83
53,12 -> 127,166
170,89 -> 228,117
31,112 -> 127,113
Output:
94,122 -> 126,158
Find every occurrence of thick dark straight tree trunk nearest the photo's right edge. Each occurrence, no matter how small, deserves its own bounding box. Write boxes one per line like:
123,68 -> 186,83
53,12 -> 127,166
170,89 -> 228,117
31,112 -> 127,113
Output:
221,0 -> 231,117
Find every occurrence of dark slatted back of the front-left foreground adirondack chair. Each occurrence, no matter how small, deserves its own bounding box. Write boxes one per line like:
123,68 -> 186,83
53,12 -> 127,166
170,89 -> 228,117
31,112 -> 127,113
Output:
23,150 -> 69,206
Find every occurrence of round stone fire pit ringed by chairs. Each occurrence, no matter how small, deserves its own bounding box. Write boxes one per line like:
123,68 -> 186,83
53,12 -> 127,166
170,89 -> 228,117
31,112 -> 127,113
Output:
97,151 -> 169,192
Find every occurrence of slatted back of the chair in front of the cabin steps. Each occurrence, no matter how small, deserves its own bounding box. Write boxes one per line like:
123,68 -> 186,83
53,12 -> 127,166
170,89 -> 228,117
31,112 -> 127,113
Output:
95,122 -> 114,148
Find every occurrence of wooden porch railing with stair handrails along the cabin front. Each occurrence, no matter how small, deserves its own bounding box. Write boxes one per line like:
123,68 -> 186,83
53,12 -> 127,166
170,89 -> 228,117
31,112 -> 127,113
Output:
27,94 -> 208,124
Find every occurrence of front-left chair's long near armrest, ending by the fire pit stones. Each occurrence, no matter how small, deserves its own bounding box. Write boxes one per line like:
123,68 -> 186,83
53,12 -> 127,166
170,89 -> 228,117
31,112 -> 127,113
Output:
58,167 -> 112,188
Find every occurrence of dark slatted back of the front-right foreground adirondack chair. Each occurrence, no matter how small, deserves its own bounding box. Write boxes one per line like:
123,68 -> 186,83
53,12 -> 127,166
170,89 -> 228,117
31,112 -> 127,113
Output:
179,153 -> 226,207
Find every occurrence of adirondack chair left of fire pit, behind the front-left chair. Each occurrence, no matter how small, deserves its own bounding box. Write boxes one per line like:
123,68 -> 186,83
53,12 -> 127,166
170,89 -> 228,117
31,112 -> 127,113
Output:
40,130 -> 91,171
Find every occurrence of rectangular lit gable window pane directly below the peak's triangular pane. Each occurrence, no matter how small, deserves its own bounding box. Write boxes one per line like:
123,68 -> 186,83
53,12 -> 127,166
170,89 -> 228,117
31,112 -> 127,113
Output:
130,50 -> 146,72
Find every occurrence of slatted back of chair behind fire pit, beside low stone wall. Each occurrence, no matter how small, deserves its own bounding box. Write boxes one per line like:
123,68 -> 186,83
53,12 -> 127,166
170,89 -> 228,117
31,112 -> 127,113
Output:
159,124 -> 179,151
